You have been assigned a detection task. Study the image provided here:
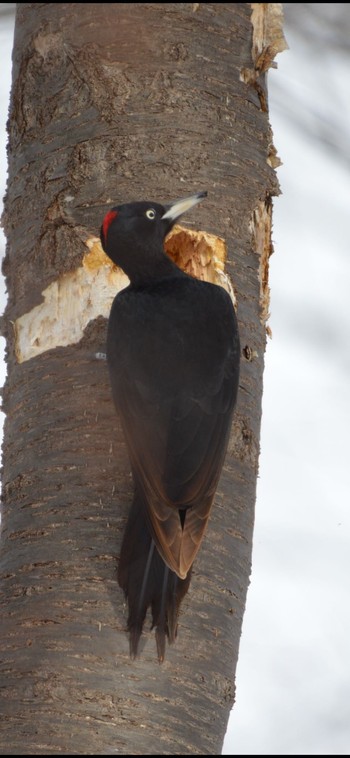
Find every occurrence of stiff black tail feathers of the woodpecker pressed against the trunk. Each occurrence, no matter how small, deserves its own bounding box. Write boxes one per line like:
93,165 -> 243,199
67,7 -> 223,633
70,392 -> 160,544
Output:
118,496 -> 191,662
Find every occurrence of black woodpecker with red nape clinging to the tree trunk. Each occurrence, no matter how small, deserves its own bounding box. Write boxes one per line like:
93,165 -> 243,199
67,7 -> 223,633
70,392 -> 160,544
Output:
100,192 -> 240,662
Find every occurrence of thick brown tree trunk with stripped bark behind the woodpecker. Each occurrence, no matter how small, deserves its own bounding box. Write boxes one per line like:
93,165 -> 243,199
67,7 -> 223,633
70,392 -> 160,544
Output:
0,3 -> 283,755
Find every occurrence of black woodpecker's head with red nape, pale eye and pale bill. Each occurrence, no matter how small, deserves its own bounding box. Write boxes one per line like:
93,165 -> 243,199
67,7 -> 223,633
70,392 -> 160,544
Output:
100,192 -> 207,279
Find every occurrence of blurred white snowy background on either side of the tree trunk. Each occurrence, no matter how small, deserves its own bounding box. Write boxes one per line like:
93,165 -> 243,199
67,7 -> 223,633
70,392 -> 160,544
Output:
0,3 -> 350,755
